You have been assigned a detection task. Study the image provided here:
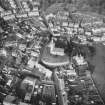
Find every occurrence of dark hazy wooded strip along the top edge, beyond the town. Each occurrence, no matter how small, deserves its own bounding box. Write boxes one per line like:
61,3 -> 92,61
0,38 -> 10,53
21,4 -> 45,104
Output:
39,0 -> 105,14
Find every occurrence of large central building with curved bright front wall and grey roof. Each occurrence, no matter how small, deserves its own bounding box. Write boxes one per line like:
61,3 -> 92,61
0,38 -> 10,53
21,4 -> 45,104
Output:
41,41 -> 69,67
